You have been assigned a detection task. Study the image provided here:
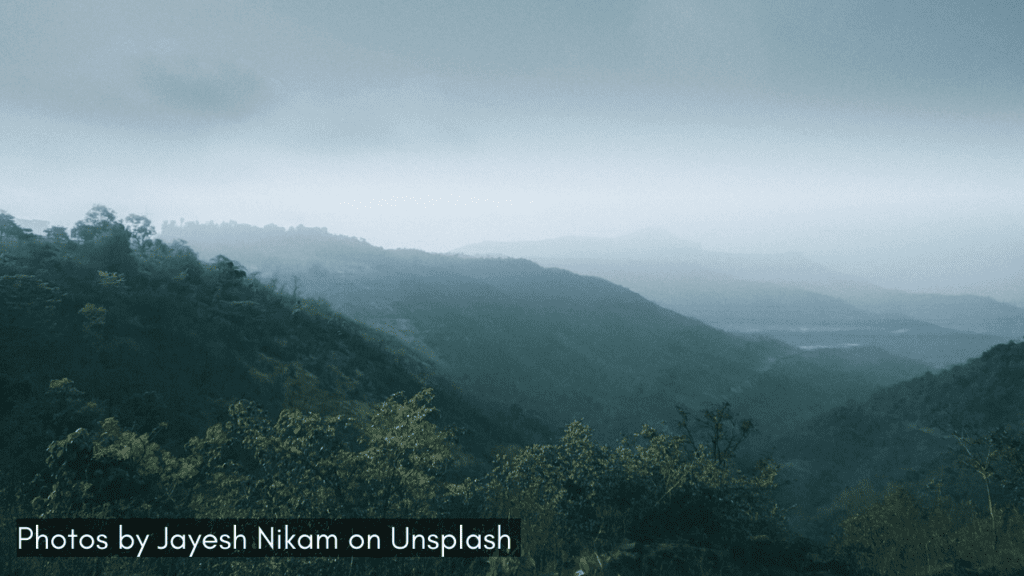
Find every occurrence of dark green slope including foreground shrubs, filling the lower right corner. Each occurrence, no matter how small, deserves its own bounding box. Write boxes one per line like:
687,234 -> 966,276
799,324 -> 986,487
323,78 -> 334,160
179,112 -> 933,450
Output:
774,336 -> 1024,574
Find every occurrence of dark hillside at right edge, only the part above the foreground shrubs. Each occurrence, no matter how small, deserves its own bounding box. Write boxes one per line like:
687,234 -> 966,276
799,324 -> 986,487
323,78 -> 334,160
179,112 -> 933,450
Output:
771,342 -> 1024,531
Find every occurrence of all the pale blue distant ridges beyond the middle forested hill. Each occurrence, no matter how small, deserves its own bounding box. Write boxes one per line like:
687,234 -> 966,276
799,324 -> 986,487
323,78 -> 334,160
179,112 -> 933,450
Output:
453,227 -> 1024,367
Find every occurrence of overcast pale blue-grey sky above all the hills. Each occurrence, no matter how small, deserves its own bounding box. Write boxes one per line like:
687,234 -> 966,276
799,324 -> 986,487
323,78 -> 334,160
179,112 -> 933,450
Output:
0,0 -> 1024,302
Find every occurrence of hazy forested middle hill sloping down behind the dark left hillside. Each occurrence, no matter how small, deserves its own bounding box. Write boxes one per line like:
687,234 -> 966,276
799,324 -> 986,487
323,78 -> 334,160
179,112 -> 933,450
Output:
162,217 -> 927,442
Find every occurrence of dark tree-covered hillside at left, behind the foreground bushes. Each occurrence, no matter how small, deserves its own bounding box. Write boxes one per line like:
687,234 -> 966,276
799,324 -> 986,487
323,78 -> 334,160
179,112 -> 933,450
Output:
0,207 -> 557,487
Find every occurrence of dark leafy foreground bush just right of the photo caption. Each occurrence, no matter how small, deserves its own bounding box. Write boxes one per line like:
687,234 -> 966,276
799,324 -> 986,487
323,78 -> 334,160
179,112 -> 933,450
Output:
485,421 -> 780,570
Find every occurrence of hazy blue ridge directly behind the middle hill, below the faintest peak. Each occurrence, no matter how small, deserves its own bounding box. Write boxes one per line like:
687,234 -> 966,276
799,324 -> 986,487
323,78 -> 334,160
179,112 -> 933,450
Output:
516,258 -> 1001,368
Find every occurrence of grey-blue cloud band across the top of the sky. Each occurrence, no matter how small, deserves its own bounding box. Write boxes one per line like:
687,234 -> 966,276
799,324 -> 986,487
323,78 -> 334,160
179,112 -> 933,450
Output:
0,0 -> 1024,135
